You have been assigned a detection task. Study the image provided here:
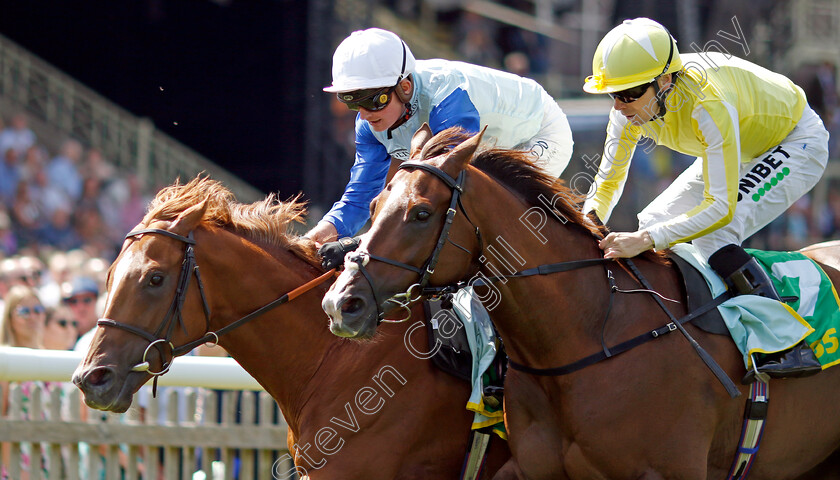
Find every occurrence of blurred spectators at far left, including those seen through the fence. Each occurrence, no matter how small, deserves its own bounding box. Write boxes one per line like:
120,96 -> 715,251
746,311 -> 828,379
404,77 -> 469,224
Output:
0,112 -> 148,480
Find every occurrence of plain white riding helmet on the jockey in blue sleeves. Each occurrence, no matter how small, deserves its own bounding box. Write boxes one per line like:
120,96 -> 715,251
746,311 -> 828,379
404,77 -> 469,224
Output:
324,28 -> 414,93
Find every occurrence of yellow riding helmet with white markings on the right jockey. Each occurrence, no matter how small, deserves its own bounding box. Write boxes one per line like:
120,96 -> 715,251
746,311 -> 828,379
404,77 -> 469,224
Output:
583,18 -> 683,93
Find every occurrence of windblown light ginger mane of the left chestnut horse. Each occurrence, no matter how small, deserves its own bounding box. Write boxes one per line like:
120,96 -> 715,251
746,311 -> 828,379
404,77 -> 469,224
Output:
143,174 -> 319,264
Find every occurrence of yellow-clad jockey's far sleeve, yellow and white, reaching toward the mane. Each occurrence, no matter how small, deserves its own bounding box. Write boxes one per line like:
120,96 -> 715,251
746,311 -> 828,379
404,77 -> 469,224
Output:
583,109 -> 639,223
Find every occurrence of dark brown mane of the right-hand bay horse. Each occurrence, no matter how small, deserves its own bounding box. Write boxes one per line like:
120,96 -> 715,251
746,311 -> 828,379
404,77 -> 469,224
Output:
420,127 -> 608,237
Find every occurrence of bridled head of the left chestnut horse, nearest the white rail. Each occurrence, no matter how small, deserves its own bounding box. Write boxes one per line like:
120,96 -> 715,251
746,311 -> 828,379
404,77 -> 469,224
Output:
73,196 -> 213,412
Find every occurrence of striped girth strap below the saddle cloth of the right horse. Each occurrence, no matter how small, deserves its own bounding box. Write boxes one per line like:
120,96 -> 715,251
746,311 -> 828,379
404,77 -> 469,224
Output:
726,381 -> 770,480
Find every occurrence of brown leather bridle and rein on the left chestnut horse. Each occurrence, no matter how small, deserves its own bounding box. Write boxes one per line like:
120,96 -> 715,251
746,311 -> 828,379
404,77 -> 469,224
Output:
96,228 -> 335,392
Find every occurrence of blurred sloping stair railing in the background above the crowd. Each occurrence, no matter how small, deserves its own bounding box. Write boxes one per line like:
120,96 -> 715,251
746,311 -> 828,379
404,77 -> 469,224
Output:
0,35 -> 265,202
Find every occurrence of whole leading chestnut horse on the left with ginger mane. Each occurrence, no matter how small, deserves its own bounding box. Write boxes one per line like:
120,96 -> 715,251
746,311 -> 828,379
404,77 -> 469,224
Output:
73,177 -> 510,480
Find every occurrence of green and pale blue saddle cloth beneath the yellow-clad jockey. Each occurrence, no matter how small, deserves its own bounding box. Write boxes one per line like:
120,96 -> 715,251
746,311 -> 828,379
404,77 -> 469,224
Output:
671,244 -> 840,369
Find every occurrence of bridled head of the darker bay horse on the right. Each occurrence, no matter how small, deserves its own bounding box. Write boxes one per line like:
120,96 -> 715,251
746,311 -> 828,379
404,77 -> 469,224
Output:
322,125 -> 483,338
